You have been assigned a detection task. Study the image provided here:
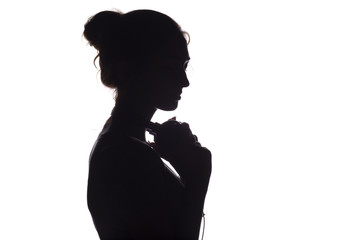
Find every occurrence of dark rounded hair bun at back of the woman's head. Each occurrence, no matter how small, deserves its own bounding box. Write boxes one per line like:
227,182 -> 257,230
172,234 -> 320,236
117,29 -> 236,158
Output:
84,11 -> 123,50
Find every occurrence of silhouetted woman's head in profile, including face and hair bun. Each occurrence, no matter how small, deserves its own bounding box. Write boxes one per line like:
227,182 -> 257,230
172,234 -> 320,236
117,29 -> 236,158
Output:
84,10 -> 189,110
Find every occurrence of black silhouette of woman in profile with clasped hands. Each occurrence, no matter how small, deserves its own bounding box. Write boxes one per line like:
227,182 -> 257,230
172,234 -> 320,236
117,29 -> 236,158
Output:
84,10 -> 211,240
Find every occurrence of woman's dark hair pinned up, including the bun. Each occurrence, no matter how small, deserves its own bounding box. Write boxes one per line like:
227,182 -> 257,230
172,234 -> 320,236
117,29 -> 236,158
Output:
84,10 -> 188,90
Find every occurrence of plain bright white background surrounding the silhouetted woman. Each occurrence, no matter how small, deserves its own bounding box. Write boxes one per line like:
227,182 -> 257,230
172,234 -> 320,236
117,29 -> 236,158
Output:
0,0 -> 360,240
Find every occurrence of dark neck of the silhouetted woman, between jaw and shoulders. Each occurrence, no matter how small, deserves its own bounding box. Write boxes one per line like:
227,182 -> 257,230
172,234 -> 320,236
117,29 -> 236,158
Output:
112,99 -> 156,141
